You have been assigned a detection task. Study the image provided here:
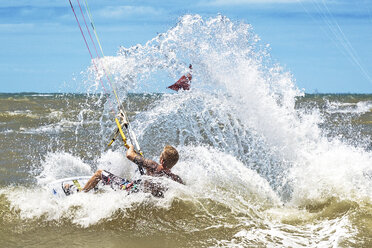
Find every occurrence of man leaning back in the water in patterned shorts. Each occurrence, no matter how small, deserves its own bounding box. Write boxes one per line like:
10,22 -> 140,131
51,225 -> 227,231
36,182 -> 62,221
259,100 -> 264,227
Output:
78,145 -> 184,196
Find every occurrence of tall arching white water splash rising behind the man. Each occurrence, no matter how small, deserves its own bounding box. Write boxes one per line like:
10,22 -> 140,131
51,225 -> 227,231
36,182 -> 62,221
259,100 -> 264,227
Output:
90,15 -> 371,205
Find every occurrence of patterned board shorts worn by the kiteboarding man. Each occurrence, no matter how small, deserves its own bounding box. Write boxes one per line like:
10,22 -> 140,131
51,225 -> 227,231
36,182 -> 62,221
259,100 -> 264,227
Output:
101,170 -> 141,193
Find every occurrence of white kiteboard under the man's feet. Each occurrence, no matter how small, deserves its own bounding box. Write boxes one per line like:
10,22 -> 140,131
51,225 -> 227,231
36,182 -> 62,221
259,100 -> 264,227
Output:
46,176 -> 91,197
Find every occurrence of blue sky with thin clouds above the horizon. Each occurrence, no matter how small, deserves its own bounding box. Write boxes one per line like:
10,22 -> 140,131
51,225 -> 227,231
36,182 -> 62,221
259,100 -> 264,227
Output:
0,0 -> 372,93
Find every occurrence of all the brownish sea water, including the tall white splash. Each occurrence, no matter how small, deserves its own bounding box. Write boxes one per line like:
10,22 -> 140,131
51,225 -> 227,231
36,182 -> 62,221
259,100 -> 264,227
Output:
0,15 -> 372,247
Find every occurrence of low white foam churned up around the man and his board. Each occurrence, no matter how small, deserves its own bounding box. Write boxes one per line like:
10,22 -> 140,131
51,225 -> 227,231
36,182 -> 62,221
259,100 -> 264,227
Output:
3,144 -> 280,227
